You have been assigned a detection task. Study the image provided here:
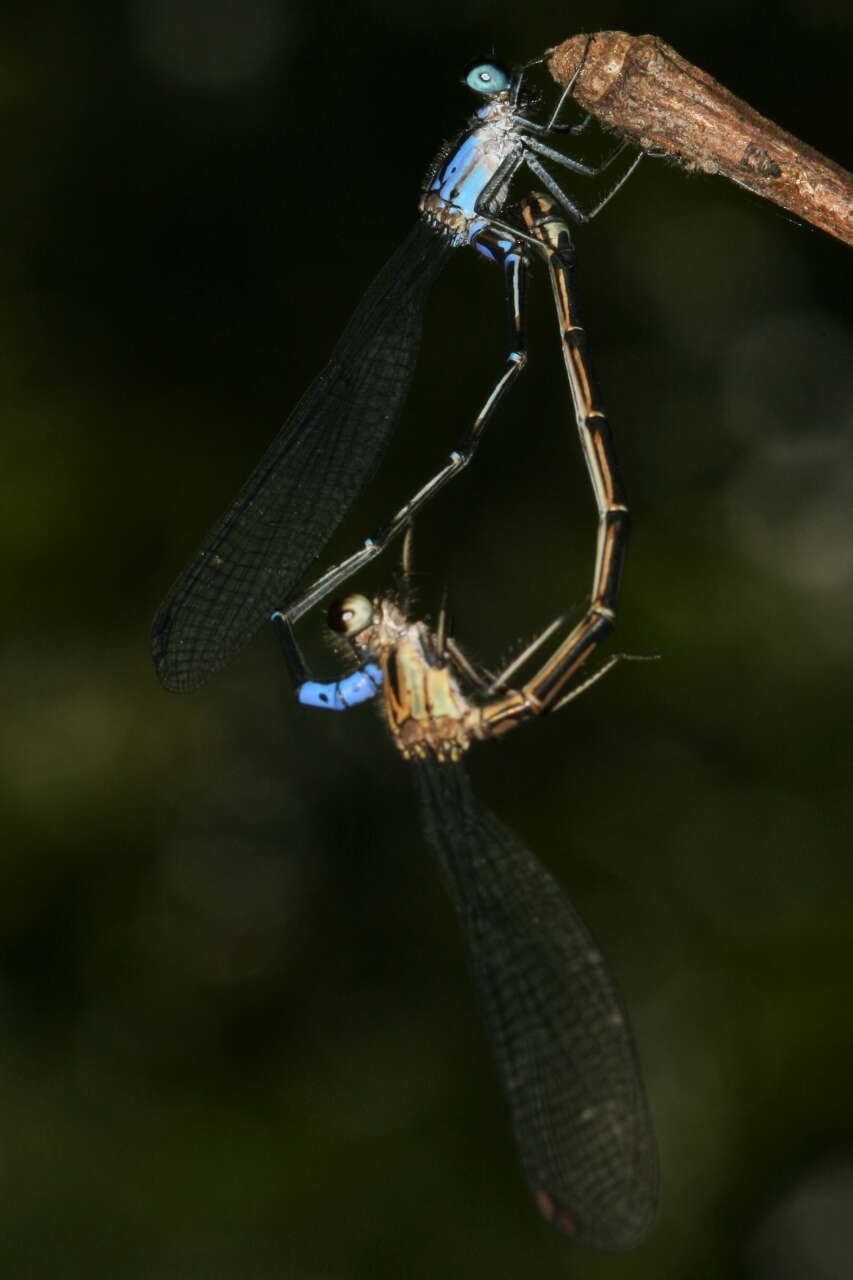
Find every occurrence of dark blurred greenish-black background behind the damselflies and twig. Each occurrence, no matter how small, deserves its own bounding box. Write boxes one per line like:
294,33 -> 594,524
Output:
0,0 -> 853,1280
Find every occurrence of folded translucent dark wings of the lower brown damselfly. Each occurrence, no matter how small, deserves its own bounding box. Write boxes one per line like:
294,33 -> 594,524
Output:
415,759 -> 657,1251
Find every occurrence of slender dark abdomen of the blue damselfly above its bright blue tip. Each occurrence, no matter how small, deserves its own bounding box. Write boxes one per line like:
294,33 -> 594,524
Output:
279,248 -> 528,622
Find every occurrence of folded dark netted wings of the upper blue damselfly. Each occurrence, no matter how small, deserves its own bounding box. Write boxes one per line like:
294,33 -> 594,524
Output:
152,220 -> 452,692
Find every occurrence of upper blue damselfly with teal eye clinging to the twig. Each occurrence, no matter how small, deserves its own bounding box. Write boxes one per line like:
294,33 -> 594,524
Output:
152,49 -> 639,691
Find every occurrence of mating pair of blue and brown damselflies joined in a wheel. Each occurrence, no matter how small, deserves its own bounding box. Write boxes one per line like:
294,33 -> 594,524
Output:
154,52 -> 656,1248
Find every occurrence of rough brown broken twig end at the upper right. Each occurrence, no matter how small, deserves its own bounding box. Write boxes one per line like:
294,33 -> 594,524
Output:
548,31 -> 853,244
